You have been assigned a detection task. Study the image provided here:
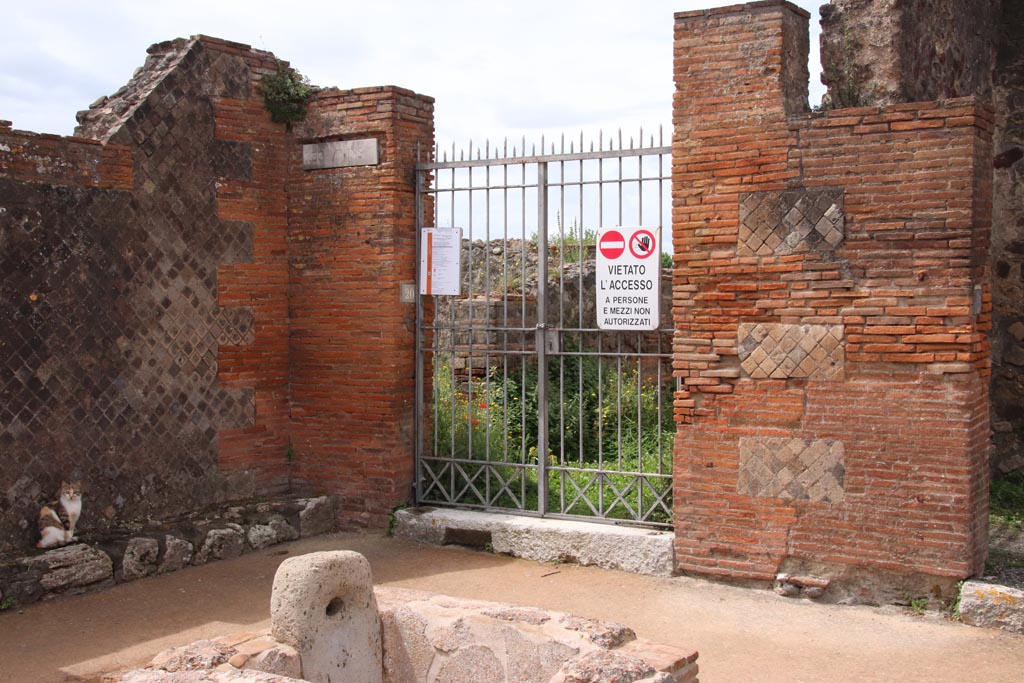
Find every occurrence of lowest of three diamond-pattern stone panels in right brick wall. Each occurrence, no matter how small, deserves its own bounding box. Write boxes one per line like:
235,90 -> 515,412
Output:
736,436 -> 846,503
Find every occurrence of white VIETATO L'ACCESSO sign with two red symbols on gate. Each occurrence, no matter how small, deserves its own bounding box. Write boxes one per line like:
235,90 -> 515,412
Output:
596,227 -> 662,331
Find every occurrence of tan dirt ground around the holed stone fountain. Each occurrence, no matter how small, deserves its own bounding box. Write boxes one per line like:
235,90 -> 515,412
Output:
0,533 -> 1024,683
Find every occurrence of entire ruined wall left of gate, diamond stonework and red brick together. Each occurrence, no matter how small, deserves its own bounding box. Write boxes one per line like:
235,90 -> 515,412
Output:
0,37 -> 432,553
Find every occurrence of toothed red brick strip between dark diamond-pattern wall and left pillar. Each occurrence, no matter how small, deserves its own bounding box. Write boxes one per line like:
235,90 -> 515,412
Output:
211,42 -> 301,492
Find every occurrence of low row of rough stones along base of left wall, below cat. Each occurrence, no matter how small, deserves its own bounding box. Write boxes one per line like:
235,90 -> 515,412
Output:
0,496 -> 335,609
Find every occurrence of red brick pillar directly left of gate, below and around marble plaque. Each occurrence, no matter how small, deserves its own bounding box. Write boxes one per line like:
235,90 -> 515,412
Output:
289,87 -> 433,526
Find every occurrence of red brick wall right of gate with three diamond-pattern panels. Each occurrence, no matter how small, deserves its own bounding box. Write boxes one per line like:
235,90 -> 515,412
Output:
673,0 -> 992,590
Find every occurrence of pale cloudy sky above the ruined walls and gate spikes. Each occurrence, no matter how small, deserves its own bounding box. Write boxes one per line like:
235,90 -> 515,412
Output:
0,0 -> 823,147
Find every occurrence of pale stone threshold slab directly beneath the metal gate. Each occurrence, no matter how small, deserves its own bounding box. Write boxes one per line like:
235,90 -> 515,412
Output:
394,507 -> 675,577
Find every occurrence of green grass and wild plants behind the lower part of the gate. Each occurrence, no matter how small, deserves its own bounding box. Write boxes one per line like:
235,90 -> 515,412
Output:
433,354 -> 675,524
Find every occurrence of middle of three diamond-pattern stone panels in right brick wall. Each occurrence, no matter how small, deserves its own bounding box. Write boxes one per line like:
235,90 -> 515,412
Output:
737,323 -> 846,380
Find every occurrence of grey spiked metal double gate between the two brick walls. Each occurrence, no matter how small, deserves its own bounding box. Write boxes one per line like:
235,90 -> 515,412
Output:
416,131 -> 675,526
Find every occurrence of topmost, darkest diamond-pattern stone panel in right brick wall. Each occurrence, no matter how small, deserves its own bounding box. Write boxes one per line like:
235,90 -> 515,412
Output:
737,189 -> 845,256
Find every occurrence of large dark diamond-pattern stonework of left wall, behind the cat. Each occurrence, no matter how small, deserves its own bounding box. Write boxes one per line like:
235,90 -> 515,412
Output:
0,43 -> 255,553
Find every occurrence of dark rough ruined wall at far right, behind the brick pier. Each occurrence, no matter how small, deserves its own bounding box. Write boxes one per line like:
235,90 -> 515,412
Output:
821,0 -> 1024,474
